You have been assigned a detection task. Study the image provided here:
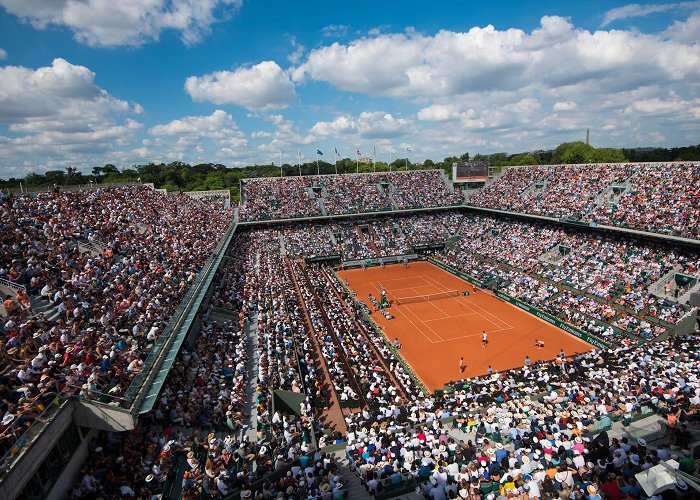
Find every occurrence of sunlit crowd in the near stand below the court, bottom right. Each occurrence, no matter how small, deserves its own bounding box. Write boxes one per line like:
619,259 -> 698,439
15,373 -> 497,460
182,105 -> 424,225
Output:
346,339 -> 700,499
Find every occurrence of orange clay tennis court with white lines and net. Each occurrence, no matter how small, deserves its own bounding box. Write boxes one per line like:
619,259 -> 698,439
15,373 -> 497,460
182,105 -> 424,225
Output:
338,262 -> 594,391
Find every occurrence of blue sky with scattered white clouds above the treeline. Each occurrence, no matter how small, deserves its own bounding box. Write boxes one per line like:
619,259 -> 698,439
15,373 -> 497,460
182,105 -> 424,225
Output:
0,0 -> 700,178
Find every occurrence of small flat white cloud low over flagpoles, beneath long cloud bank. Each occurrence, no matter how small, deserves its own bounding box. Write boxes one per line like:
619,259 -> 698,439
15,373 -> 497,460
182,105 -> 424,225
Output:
311,111 -> 415,139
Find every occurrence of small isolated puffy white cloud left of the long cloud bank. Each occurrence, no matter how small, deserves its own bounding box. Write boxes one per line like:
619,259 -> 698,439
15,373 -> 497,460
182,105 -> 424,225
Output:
185,61 -> 296,110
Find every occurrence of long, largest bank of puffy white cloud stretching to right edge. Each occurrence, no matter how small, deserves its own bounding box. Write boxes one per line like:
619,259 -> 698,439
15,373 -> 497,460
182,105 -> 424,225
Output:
292,16 -> 700,97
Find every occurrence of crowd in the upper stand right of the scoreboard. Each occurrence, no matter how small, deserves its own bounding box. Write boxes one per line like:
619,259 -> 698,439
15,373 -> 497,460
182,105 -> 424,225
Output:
469,163 -> 700,239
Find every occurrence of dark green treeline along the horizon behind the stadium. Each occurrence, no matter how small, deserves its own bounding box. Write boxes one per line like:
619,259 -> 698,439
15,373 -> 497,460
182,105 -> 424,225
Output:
0,142 -> 700,200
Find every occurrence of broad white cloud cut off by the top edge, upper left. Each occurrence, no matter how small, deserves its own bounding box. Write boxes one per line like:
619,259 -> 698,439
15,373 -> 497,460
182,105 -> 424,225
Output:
0,0 -> 242,47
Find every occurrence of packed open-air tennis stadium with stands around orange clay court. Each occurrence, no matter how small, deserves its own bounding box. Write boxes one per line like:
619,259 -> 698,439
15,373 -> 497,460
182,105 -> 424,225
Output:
0,162 -> 700,499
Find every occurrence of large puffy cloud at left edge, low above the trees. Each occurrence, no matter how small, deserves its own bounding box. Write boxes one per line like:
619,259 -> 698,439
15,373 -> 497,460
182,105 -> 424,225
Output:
0,59 -> 142,172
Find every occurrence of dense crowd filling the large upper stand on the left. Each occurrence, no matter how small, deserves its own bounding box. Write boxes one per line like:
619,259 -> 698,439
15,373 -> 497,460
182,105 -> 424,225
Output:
0,186 -> 231,458
